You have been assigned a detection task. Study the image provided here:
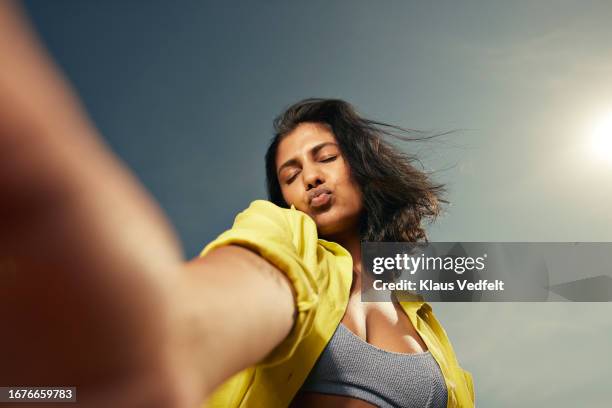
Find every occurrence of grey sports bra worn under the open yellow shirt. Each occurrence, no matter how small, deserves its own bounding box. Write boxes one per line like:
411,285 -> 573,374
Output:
300,323 -> 448,408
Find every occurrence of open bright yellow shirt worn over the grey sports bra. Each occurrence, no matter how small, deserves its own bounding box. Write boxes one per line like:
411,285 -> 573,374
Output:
200,200 -> 474,408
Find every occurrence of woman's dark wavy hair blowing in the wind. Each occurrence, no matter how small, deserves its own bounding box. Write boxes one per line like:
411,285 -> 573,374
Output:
265,98 -> 448,242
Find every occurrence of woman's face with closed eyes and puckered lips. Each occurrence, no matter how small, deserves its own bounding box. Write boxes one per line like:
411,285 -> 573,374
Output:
276,122 -> 363,237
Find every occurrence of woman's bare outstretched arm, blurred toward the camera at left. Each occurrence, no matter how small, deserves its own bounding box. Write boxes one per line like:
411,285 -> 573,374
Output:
0,0 -> 294,407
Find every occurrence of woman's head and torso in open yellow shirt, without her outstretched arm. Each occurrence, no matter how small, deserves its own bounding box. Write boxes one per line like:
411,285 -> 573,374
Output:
202,99 -> 474,407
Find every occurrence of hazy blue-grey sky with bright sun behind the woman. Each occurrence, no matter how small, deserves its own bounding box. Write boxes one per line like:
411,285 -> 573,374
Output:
26,0 -> 612,407
